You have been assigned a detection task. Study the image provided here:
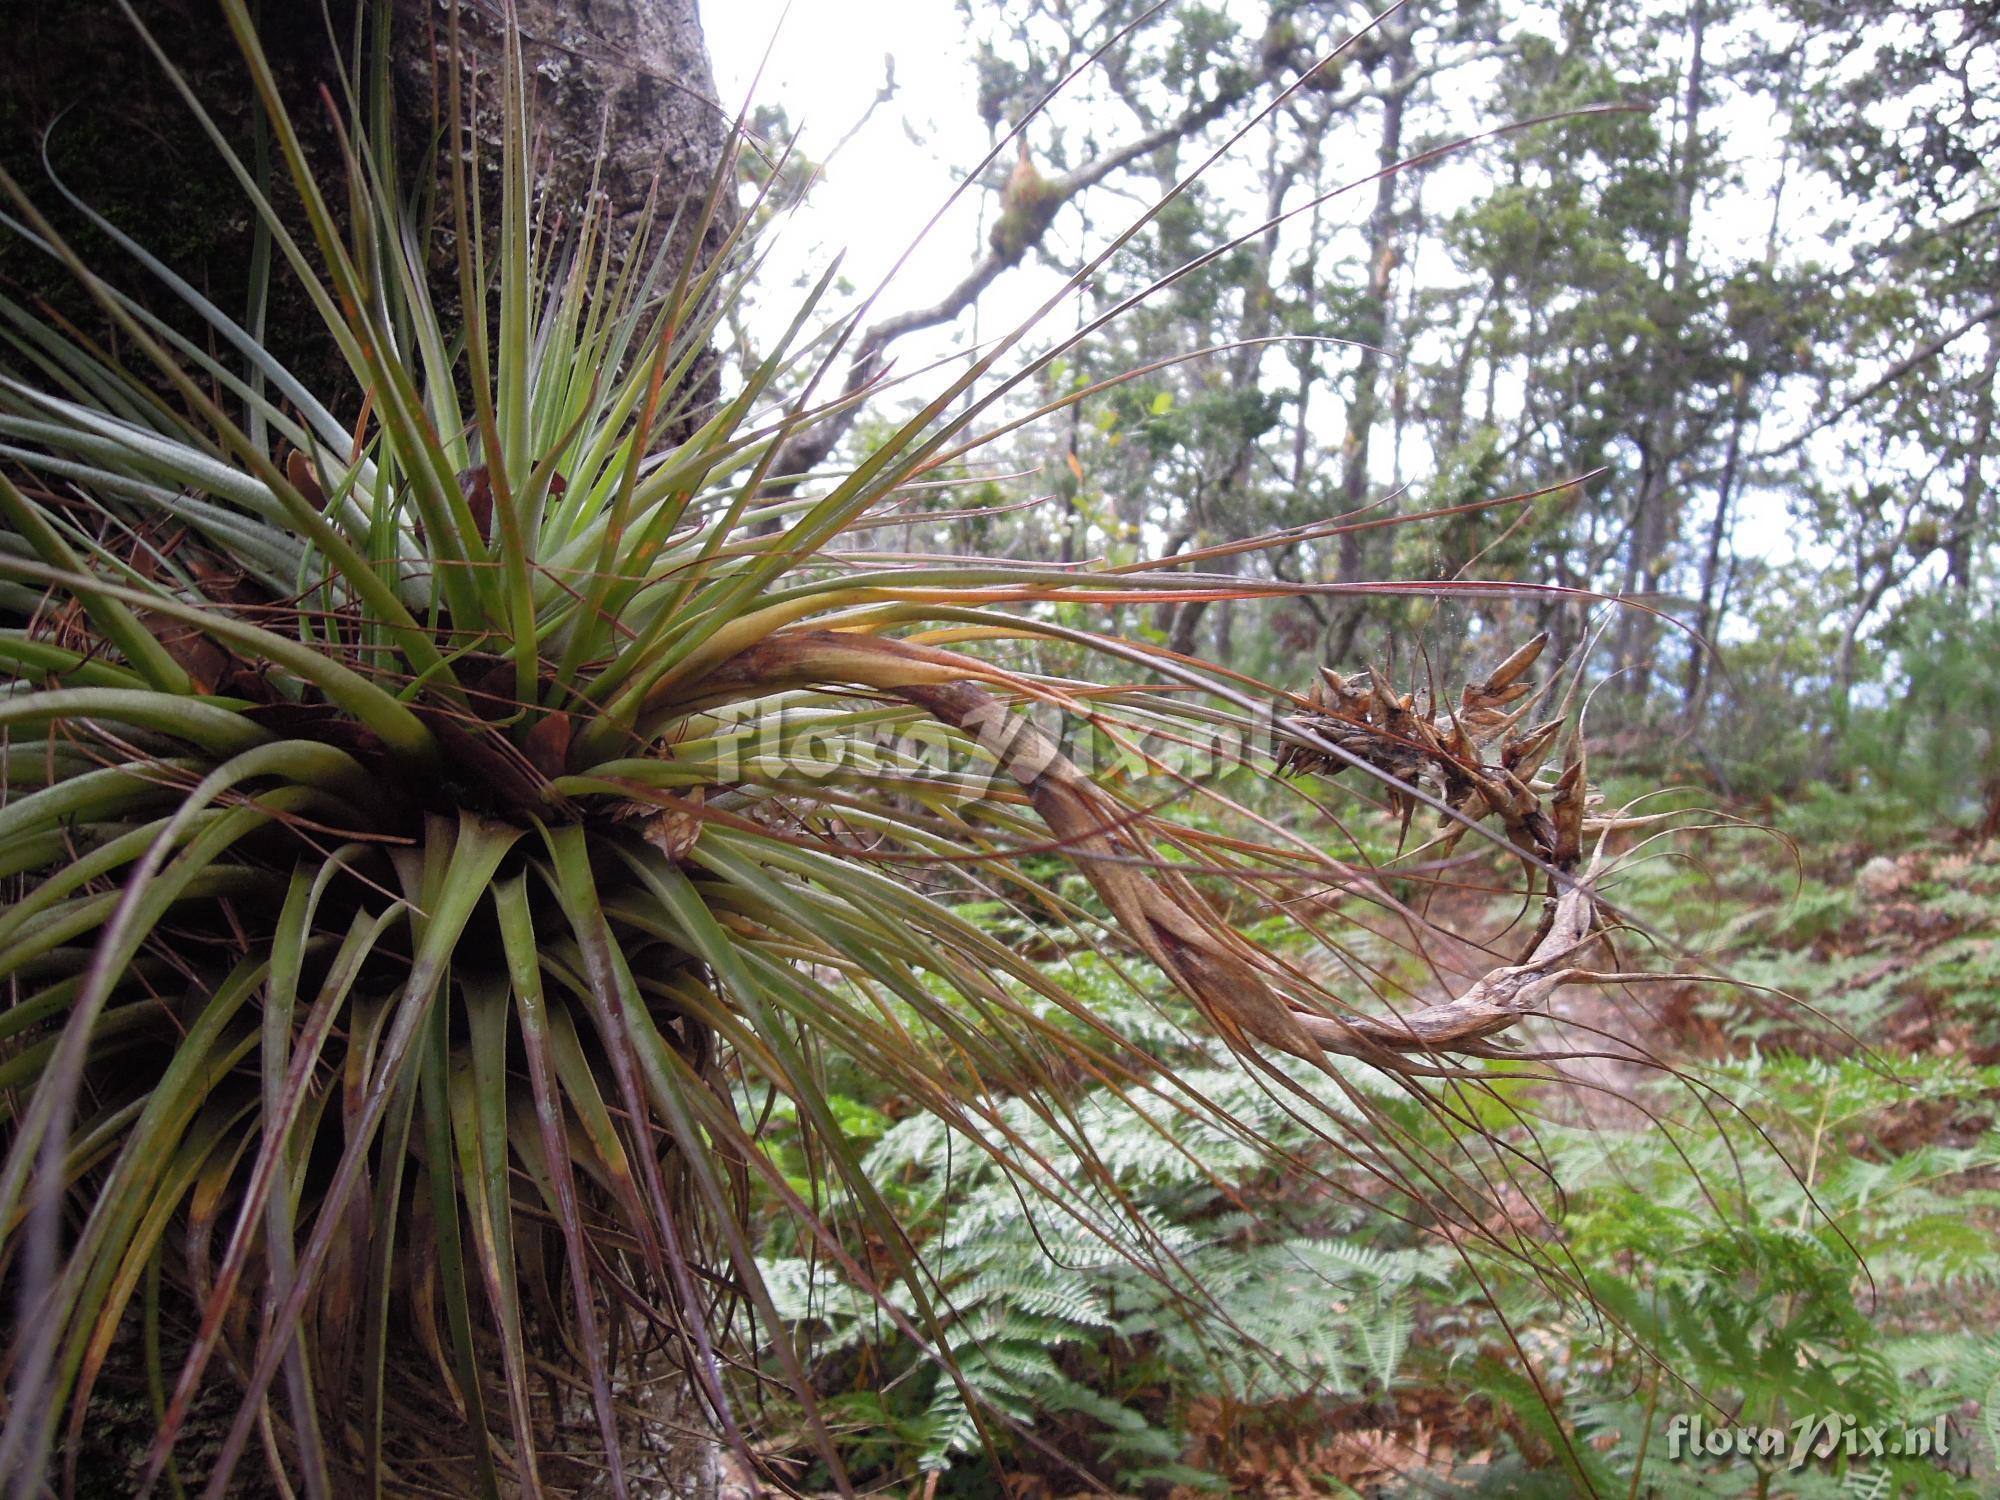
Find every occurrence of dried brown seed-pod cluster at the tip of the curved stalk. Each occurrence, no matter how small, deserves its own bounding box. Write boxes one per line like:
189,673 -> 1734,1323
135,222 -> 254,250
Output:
1278,630 -> 1588,870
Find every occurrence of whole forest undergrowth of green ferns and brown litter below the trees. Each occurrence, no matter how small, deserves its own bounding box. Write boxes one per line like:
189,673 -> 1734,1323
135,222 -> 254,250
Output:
748,790 -> 2000,1500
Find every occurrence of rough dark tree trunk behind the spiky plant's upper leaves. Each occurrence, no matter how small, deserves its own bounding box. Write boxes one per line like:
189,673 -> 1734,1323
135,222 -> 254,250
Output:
0,0 -> 734,406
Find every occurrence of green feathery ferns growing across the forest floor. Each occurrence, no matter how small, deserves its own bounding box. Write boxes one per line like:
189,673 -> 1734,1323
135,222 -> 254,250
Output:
748,836 -> 2000,1500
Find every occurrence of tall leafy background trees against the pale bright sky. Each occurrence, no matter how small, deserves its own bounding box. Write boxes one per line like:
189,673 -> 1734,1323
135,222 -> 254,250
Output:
732,0 -> 1996,812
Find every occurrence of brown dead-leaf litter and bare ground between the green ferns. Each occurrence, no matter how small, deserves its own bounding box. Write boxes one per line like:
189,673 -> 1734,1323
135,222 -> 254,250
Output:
1174,816 -> 2000,1500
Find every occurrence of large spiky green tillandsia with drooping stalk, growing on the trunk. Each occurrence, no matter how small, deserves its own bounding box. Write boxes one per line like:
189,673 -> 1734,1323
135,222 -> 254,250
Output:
0,0 -> 1664,1496
